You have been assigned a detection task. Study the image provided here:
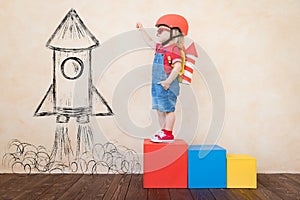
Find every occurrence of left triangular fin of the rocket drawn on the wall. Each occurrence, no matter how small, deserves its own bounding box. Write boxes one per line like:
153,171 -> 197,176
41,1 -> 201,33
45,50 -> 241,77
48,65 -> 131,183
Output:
34,84 -> 55,117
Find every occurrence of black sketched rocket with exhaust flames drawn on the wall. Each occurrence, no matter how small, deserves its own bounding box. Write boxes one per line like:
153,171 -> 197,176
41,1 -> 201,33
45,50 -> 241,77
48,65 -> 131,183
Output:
34,9 -> 113,164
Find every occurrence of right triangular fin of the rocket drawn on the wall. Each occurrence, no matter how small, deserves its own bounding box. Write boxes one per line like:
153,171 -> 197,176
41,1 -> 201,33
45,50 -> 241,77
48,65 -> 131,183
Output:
92,85 -> 114,116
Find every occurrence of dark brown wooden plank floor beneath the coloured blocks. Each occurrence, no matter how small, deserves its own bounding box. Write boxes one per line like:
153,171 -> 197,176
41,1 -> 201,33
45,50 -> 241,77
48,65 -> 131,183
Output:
0,174 -> 300,200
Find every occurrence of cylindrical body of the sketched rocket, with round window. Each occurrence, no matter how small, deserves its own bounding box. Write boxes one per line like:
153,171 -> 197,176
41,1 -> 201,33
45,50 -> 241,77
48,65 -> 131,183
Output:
53,50 -> 92,117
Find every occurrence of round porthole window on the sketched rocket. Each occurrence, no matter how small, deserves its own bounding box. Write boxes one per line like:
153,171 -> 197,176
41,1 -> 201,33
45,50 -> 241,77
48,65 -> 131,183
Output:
61,57 -> 83,80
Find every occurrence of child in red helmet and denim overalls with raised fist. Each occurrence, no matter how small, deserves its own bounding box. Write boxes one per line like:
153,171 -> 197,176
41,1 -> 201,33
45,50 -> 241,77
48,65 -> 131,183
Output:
136,14 -> 188,142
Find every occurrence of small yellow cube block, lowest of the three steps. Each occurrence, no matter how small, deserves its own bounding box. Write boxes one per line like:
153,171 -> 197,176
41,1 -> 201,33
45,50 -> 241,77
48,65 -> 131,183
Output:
226,154 -> 257,188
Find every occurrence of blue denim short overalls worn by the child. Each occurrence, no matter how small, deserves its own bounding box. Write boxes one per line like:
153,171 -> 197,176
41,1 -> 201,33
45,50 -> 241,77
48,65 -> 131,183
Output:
151,53 -> 179,112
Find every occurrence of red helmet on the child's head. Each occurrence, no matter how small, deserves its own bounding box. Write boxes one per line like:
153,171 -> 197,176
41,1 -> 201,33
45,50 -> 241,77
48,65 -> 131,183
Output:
155,14 -> 189,36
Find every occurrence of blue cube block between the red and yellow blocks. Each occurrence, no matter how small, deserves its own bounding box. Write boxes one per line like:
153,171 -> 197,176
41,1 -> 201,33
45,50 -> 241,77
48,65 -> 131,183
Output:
188,145 -> 226,188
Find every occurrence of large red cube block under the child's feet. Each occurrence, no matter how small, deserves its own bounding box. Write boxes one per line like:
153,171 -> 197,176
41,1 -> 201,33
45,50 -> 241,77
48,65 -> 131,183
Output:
144,139 -> 188,188
